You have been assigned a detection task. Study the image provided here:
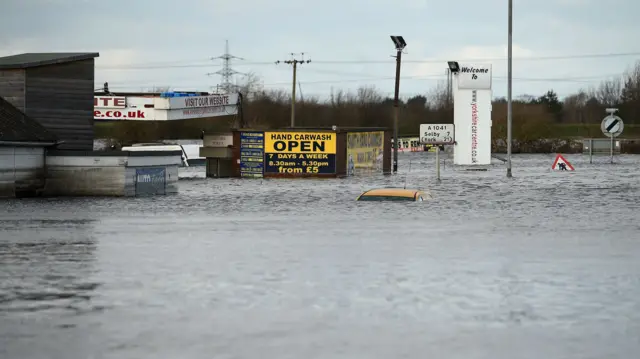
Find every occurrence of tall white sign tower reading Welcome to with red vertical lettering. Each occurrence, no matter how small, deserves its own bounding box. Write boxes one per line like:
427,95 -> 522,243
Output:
453,63 -> 493,166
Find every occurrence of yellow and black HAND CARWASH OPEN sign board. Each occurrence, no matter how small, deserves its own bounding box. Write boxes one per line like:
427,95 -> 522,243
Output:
264,132 -> 336,175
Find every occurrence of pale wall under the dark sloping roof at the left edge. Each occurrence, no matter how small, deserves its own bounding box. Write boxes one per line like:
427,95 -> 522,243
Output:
0,147 -> 45,198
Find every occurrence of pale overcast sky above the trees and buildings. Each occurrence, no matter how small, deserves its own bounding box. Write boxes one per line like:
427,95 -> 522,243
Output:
0,0 -> 640,101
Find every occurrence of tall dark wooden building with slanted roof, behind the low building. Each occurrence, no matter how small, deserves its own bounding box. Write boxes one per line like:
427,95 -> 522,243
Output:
0,53 -> 99,151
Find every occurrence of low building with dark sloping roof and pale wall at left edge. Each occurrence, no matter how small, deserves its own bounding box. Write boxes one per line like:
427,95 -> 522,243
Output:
0,97 -> 57,198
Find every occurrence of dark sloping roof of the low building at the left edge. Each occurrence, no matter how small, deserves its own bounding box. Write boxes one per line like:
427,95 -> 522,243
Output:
0,97 -> 57,143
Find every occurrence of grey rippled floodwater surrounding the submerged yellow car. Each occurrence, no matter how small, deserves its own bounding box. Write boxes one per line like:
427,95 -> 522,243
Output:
0,153 -> 640,359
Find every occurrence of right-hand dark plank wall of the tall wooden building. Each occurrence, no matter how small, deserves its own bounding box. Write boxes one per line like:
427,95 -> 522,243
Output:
24,59 -> 95,151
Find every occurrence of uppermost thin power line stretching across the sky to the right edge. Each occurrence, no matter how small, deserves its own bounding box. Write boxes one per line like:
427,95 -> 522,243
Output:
96,52 -> 640,70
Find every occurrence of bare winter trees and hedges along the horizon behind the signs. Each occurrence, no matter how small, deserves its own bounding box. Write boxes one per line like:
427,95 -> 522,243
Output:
98,61 -> 640,152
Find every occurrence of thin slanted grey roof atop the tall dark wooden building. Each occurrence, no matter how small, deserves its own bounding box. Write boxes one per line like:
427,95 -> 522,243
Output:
0,52 -> 100,70
